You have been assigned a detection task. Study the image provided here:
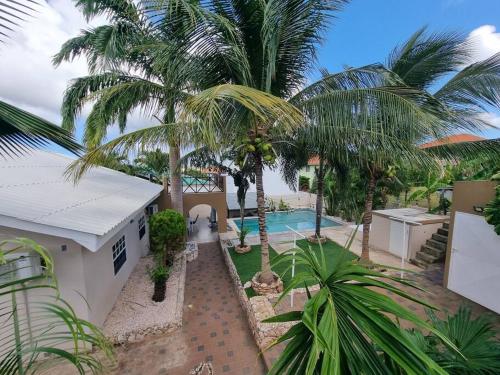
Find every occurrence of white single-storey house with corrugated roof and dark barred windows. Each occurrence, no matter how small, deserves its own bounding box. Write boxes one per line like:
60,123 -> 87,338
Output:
0,151 -> 163,325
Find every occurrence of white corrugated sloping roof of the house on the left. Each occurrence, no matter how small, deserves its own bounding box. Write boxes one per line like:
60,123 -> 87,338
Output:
0,151 -> 163,251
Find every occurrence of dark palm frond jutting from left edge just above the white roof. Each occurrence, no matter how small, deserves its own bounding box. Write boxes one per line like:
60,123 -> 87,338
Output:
0,101 -> 82,156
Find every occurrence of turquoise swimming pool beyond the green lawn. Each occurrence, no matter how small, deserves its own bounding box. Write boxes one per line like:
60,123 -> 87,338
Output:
233,210 -> 340,235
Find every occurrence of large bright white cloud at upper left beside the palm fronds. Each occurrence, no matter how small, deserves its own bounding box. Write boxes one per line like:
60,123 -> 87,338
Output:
0,0 -> 151,139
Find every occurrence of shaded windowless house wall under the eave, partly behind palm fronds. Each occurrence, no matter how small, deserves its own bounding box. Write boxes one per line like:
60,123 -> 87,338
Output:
0,226 -> 89,319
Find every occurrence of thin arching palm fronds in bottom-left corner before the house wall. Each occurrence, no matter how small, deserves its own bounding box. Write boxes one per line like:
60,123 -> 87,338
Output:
0,238 -> 113,375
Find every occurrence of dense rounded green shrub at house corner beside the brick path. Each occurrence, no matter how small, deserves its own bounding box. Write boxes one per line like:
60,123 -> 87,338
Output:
149,210 -> 187,265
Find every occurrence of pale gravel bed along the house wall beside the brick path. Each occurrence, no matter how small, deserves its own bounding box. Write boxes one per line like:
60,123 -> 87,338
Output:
103,253 -> 186,344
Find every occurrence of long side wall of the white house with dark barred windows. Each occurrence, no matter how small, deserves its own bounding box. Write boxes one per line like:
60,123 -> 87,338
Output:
83,211 -> 149,326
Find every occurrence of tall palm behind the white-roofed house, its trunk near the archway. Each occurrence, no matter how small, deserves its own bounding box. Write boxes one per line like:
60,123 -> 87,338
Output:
54,0 -> 221,213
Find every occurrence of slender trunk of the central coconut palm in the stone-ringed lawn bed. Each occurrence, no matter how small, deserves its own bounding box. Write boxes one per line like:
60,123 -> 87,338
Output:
255,155 -> 274,284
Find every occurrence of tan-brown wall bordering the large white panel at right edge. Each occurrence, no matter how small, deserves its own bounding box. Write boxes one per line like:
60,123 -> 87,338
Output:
444,181 -> 496,287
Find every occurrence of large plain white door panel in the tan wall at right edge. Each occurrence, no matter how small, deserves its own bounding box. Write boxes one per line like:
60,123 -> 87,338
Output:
448,212 -> 500,314
